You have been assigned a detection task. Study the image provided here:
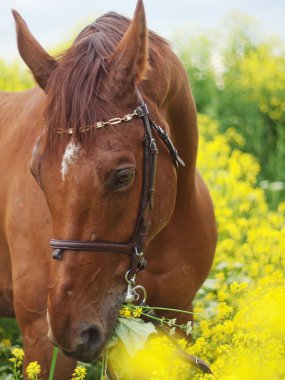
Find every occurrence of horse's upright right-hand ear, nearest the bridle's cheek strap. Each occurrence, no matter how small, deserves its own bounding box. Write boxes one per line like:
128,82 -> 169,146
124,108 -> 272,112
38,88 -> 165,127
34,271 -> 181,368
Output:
110,0 -> 149,89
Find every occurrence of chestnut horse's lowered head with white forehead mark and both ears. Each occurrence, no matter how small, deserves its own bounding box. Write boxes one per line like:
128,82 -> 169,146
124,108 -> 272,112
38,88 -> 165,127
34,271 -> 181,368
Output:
13,0 -> 176,361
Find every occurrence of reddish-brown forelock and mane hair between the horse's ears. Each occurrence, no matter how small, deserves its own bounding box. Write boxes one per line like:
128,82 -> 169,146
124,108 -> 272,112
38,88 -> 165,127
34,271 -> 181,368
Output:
44,12 -> 167,143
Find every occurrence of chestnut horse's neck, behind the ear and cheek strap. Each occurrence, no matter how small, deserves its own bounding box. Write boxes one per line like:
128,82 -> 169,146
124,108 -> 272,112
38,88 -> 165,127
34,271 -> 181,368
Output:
143,46 -> 198,185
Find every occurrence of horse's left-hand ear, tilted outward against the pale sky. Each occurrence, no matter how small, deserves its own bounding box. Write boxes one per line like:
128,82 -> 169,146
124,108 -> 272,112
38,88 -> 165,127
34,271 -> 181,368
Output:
12,9 -> 57,90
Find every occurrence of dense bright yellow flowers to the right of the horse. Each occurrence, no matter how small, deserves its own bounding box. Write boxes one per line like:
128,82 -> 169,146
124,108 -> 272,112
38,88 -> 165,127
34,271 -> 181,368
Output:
186,116 -> 285,380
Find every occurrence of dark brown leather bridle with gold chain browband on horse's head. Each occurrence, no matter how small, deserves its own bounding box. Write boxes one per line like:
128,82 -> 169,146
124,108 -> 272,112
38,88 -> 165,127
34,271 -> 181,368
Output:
50,90 -> 185,282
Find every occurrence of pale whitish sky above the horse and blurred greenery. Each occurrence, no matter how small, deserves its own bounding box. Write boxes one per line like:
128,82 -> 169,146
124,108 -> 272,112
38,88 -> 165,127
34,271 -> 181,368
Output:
0,0 -> 285,60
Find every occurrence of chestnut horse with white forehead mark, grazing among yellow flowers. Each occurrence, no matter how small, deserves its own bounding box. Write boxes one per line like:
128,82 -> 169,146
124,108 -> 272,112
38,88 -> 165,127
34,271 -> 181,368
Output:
0,0 -> 216,380
